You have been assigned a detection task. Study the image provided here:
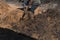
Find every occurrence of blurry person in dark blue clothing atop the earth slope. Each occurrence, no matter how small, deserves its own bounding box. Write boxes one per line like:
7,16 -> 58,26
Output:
22,0 -> 41,18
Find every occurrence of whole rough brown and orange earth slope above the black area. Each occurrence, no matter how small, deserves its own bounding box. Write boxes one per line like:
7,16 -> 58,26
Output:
0,0 -> 60,40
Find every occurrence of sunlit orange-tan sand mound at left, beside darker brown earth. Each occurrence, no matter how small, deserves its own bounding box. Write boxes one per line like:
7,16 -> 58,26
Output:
0,1 -> 23,28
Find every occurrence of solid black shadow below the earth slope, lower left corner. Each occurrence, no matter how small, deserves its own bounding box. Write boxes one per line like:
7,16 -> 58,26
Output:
0,28 -> 36,40
